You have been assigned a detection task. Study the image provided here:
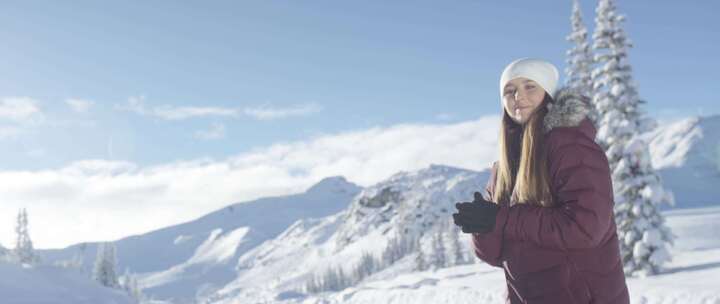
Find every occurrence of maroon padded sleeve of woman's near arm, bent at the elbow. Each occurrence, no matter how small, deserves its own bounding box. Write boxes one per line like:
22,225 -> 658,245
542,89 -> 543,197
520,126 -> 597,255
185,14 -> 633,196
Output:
499,138 -> 614,250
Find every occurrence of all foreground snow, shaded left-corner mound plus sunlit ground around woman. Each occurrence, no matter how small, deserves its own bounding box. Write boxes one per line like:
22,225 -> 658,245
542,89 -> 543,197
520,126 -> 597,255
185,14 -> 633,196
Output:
7,201 -> 720,304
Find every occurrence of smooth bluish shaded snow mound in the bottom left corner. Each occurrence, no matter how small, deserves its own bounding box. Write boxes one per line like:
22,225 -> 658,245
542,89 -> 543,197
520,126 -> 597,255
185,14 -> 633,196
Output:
0,262 -> 134,304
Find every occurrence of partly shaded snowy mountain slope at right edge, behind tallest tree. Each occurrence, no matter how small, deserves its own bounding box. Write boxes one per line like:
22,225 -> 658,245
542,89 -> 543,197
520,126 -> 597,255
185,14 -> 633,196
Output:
643,115 -> 720,209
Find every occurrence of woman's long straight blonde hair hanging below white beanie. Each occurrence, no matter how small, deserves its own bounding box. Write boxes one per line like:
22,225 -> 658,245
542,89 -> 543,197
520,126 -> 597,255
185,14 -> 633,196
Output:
492,93 -> 552,207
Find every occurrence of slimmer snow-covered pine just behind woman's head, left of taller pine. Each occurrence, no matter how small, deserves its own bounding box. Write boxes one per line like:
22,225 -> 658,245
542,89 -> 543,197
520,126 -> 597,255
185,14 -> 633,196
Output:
565,0 -> 595,105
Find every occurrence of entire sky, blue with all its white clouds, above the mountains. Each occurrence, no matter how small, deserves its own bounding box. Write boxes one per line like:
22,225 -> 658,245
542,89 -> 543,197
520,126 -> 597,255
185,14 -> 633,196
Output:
0,0 -> 720,247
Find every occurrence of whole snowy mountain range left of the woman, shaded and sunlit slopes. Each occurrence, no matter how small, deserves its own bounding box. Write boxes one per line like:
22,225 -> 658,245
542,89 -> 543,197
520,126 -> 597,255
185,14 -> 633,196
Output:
36,165 -> 488,303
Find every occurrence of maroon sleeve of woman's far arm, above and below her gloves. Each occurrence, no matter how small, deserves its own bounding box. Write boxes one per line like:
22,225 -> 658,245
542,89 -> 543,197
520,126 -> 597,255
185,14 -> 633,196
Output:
472,162 -> 507,267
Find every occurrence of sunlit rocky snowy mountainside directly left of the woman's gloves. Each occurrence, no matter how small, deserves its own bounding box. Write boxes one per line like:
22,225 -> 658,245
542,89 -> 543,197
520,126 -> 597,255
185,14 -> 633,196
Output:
204,165 -> 488,303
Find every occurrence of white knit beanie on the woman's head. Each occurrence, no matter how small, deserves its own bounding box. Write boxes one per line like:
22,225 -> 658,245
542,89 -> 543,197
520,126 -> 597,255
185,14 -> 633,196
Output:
500,58 -> 560,100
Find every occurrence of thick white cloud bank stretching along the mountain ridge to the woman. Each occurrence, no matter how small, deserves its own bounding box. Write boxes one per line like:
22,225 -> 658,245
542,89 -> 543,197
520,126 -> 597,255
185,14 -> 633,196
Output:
0,116 -> 499,248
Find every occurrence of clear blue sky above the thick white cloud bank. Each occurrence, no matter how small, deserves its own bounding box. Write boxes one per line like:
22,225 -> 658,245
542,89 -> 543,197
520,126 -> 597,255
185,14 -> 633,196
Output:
0,1 -> 720,169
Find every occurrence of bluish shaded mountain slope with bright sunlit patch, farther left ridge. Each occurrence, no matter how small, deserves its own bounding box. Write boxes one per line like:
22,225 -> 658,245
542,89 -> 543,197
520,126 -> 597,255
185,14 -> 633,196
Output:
40,177 -> 360,303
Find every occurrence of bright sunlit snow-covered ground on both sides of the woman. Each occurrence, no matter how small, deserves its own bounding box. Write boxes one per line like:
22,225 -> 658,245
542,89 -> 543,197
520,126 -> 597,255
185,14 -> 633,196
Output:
207,206 -> 720,304
